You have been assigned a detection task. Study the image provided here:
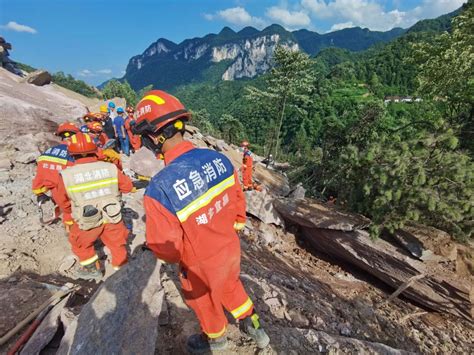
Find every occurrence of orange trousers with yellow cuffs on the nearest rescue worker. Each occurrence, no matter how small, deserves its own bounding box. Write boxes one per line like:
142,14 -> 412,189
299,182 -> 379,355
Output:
180,241 -> 253,338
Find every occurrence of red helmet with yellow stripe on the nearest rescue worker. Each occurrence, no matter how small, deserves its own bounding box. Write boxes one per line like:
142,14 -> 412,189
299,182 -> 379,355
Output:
134,90 -> 191,134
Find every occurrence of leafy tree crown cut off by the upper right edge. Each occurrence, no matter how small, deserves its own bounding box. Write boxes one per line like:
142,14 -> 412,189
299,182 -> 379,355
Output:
411,1 -> 474,155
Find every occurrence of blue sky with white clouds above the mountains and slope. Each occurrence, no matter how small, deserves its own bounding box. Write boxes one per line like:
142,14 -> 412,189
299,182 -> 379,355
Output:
0,0 -> 466,85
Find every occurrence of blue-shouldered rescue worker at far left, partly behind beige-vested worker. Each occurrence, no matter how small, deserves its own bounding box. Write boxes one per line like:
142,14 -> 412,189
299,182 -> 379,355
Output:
33,122 -> 79,219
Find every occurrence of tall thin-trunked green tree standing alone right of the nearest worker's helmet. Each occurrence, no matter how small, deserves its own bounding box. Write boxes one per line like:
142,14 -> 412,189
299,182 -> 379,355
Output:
247,46 -> 314,159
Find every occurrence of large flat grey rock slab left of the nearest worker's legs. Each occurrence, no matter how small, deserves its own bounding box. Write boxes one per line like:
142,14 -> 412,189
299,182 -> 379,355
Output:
57,248 -> 164,354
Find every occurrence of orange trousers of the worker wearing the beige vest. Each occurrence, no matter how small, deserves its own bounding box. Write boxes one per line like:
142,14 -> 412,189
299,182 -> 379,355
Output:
69,221 -> 128,267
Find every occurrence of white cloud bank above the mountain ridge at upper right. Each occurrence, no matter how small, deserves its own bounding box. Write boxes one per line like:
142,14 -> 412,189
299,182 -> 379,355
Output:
301,0 -> 466,31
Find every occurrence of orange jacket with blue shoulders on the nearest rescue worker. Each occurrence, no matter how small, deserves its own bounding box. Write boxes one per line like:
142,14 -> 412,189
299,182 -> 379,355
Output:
144,142 -> 246,266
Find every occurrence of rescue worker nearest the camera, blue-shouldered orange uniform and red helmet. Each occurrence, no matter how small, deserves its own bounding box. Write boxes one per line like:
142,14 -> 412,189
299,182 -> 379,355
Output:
134,90 -> 270,353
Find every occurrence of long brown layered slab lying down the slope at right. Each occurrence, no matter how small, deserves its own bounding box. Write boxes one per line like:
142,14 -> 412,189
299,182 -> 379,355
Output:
274,199 -> 474,321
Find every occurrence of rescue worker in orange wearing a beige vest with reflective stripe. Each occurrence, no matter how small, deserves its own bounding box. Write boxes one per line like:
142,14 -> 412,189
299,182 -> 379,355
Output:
58,133 -> 133,279
